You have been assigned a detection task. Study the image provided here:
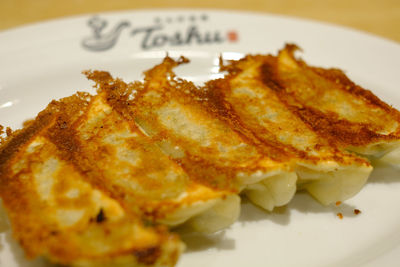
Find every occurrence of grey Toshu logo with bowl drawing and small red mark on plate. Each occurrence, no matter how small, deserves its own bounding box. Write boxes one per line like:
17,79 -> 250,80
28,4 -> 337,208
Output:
82,14 -> 239,51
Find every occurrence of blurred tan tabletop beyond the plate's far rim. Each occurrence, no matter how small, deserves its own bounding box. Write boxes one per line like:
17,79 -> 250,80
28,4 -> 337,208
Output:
0,0 -> 400,42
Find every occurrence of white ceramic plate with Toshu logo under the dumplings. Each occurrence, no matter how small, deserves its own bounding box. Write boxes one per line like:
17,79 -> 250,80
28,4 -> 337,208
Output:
0,10 -> 400,267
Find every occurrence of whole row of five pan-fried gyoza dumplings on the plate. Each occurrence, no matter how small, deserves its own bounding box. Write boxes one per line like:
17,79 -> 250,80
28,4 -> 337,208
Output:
0,45 -> 400,266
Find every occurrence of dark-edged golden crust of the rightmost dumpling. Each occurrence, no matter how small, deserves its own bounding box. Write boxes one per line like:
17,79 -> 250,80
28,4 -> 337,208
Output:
260,45 -> 400,152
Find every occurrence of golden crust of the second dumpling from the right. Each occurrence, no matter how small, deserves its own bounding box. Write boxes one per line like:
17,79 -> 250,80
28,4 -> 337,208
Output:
214,52 -> 369,166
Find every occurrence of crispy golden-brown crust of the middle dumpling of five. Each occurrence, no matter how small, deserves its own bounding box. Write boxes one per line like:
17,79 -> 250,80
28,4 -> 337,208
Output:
87,57 -> 290,192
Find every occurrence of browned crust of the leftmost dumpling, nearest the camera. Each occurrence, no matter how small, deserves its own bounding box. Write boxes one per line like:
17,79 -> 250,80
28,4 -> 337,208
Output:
0,94 -> 182,266
